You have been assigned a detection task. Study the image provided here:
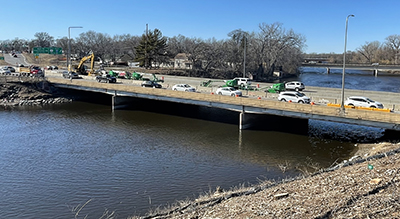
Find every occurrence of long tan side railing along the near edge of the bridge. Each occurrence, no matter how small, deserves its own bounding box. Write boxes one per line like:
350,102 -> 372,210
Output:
48,78 -> 400,128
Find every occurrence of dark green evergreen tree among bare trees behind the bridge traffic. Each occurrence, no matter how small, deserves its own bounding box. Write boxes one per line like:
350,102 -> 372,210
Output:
135,29 -> 167,68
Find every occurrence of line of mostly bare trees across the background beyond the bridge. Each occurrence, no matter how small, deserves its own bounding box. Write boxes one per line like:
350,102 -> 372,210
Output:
0,23 -> 400,80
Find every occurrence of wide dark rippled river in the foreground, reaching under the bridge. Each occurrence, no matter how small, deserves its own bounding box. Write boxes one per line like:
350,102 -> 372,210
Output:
0,67 -> 390,218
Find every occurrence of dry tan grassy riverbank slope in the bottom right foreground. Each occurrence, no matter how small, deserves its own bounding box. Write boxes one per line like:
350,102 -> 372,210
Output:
134,143 -> 400,218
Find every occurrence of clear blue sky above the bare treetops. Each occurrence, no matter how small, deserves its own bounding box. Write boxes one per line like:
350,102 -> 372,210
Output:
0,0 -> 400,53
